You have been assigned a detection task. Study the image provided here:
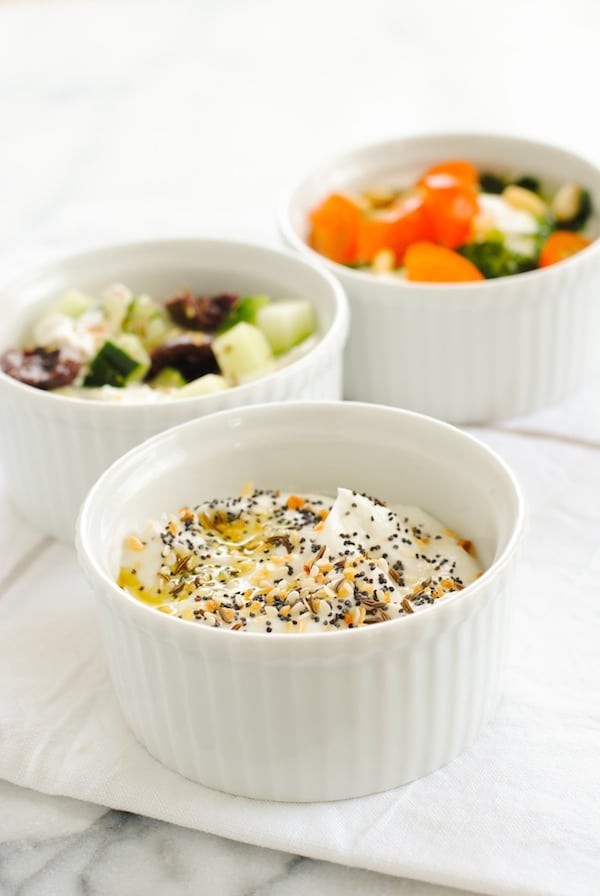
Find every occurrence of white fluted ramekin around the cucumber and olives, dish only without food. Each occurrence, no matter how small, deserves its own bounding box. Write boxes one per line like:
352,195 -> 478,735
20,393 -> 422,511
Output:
0,239 -> 348,541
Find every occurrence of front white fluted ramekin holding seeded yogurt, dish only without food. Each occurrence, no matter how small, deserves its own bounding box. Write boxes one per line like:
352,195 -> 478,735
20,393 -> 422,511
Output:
76,402 -> 524,801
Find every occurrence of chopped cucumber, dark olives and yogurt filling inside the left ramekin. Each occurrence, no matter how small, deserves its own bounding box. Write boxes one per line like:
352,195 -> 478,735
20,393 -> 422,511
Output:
0,284 -> 316,400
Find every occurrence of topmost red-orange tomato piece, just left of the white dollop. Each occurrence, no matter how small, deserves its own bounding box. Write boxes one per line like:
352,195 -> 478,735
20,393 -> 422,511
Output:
424,173 -> 479,249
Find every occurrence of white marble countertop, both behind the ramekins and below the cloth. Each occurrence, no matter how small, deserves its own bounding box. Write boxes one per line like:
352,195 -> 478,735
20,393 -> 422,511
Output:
0,0 -> 600,896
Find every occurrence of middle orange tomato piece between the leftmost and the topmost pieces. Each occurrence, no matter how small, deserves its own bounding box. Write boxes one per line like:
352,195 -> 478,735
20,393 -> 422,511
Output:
358,194 -> 430,264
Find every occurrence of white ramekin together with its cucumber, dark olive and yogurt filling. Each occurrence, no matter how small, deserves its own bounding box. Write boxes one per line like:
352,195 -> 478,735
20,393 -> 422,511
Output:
0,238 -> 349,541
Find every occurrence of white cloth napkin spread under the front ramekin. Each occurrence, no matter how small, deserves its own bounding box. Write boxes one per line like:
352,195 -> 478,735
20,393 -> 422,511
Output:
0,430 -> 600,896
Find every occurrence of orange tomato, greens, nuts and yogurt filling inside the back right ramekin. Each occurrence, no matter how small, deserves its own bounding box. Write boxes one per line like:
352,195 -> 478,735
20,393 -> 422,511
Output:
308,159 -> 592,283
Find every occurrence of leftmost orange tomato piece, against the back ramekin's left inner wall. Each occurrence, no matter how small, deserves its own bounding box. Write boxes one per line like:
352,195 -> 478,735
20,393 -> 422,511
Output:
308,193 -> 362,264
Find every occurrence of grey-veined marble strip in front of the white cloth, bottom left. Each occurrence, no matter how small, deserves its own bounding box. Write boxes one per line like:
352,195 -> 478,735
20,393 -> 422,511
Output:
0,781 -> 478,896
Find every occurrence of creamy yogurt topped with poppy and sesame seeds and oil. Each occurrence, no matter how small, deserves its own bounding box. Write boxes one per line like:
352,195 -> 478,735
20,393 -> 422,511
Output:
118,484 -> 481,633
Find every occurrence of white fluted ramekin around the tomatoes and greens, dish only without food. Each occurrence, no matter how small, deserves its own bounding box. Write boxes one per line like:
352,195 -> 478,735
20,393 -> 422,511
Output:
280,134 -> 600,423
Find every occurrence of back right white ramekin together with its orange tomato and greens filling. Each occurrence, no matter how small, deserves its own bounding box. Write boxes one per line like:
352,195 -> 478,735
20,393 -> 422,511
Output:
280,134 -> 600,423
